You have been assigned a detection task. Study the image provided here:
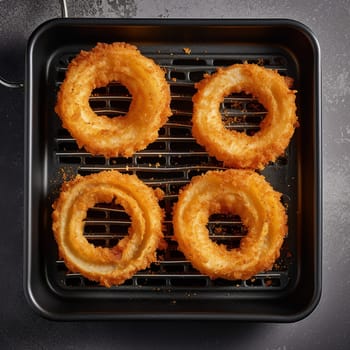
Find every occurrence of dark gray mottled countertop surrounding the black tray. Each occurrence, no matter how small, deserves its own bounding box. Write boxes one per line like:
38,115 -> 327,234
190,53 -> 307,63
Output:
0,0 -> 350,350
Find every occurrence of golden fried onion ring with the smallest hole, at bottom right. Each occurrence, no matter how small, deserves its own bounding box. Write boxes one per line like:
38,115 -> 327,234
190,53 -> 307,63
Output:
173,169 -> 287,280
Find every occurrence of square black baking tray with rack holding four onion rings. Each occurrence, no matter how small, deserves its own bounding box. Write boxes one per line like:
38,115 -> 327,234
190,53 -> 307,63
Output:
24,19 -> 322,322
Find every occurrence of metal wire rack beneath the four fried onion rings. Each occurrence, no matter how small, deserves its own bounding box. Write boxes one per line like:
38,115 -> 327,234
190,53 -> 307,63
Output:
52,50 -> 295,291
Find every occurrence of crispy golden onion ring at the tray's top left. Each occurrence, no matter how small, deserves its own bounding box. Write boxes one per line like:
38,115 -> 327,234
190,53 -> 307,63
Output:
55,43 -> 171,158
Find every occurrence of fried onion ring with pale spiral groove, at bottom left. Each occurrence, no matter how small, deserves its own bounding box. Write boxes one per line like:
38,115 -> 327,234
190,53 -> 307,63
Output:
52,171 -> 164,287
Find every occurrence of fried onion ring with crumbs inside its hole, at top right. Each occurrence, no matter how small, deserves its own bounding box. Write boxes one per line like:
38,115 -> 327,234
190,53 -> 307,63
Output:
192,63 -> 298,169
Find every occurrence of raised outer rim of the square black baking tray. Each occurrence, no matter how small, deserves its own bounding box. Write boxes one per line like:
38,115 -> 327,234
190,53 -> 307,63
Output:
24,18 -> 322,322
